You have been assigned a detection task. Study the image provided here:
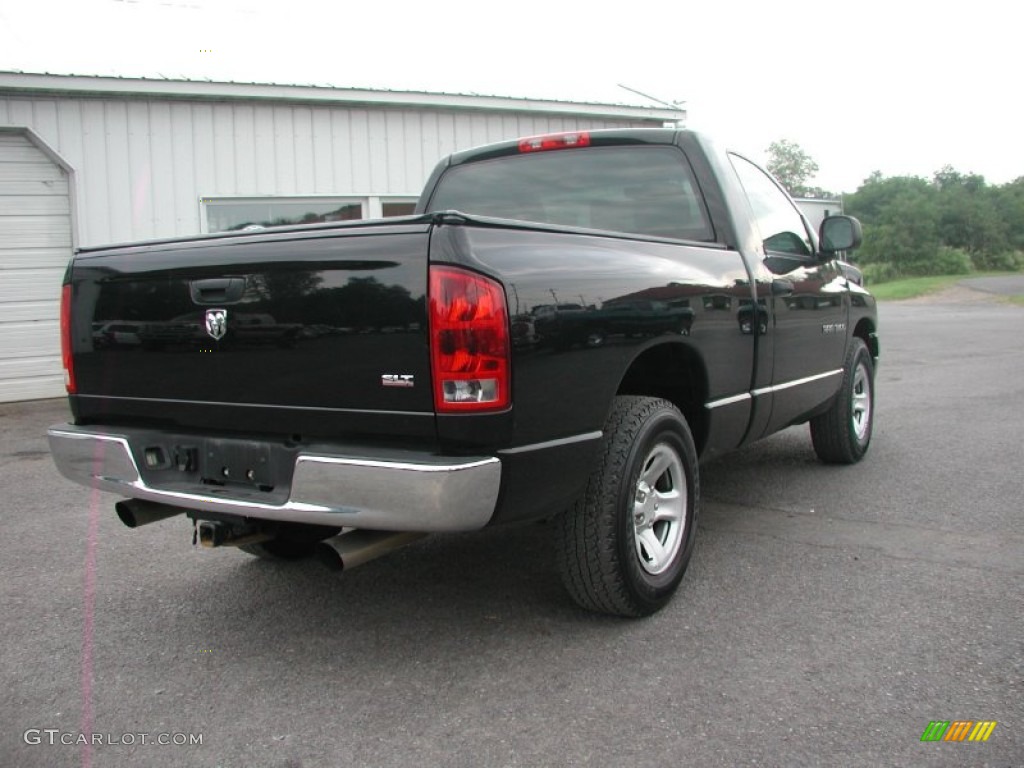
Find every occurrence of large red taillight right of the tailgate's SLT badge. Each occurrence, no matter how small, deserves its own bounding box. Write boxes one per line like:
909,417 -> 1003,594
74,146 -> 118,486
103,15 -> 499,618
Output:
430,266 -> 511,413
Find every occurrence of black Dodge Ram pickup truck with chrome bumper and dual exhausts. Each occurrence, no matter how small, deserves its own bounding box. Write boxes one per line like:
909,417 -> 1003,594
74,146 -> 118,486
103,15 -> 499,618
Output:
49,129 -> 879,616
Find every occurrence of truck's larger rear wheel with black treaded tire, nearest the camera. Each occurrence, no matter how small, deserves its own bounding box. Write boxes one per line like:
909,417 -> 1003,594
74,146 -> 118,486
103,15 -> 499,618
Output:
556,396 -> 700,616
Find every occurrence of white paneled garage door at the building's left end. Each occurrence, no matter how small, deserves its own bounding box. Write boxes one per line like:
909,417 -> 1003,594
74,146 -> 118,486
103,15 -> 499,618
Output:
0,128 -> 72,402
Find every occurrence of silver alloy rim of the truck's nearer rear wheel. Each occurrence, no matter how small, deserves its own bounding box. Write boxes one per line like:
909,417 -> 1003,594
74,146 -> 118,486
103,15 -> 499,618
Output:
633,442 -> 686,575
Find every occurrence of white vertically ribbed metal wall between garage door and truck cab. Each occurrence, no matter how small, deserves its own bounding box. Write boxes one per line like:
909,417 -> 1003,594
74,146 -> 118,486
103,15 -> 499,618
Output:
0,95 -> 649,246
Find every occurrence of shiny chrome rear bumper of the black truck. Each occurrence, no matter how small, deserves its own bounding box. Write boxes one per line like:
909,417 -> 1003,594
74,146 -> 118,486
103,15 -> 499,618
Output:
47,424 -> 502,531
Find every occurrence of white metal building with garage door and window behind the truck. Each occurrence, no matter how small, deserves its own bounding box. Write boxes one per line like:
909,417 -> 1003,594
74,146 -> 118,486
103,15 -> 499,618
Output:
0,73 -> 685,401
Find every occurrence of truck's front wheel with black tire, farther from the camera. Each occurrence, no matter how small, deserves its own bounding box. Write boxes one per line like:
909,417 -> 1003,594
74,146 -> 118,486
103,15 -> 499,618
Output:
811,337 -> 874,464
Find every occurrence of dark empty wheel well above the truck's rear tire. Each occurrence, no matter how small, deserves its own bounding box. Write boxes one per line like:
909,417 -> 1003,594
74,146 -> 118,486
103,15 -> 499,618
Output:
615,343 -> 708,455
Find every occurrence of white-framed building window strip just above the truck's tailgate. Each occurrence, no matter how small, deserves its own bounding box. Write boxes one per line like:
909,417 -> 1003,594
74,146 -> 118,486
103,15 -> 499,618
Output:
200,196 -> 416,232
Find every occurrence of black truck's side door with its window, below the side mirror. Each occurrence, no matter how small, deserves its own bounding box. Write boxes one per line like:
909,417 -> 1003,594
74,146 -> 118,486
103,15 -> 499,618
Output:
730,155 -> 850,437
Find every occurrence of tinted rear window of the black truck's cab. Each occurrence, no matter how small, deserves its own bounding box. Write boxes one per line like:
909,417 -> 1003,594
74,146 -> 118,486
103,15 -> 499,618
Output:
427,146 -> 715,243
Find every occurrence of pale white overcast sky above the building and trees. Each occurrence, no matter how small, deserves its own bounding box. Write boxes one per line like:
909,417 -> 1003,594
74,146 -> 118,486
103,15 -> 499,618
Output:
0,0 -> 1024,191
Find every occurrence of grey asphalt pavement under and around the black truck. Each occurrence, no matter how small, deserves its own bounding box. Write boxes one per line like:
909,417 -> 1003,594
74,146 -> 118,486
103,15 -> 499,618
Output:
0,290 -> 1024,768
